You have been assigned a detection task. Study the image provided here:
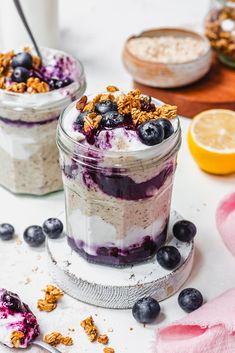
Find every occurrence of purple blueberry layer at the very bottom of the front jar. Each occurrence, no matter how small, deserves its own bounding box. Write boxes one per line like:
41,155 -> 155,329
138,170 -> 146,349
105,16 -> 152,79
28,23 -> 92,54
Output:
68,222 -> 168,267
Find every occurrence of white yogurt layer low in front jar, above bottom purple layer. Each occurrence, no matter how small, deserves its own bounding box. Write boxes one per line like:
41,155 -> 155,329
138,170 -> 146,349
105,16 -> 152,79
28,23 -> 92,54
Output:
68,209 -> 166,255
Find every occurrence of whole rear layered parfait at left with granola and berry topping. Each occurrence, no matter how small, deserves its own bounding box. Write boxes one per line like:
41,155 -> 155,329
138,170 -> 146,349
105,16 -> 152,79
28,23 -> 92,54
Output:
0,48 -> 85,195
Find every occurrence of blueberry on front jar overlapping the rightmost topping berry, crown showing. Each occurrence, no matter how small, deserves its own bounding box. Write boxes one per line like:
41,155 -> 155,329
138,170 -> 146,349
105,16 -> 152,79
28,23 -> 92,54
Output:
138,120 -> 164,146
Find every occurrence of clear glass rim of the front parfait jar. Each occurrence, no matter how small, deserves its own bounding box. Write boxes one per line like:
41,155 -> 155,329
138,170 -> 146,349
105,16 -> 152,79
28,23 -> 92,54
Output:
57,91 -> 181,165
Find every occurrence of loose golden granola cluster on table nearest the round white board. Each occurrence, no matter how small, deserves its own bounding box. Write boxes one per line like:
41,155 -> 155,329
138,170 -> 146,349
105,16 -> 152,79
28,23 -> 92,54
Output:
37,284 -> 64,312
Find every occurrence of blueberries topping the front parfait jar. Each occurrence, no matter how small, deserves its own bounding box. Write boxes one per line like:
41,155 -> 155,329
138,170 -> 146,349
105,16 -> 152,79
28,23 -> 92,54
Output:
76,97 -> 174,146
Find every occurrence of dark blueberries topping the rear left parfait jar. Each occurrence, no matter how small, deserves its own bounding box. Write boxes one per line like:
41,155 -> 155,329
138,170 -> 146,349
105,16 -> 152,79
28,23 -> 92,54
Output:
11,52 -> 72,90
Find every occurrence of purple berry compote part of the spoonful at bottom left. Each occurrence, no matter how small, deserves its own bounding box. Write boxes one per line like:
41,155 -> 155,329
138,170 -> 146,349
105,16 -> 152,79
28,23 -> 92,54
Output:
0,289 -> 40,348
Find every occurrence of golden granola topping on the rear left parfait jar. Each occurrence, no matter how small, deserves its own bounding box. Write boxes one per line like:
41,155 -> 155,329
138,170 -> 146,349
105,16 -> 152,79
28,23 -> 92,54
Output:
0,48 -> 50,94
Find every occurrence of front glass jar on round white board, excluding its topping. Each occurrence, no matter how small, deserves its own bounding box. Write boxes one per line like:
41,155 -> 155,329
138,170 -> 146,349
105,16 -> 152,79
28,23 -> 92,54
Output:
57,95 -> 181,267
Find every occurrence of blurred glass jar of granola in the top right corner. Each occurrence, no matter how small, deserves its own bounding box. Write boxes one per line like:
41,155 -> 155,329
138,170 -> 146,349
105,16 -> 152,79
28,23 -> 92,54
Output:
205,0 -> 235,67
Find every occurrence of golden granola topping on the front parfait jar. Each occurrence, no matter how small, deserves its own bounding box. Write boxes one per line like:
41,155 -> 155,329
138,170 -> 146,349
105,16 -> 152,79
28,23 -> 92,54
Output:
76,86 -> 177,134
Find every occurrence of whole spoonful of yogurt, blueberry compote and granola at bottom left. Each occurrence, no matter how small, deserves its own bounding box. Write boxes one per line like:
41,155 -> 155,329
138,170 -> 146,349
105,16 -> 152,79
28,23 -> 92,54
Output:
0,288 -> 39,348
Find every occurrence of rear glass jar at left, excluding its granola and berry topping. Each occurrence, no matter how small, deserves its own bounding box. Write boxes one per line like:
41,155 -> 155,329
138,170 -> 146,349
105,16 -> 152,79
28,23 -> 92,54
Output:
0,48 -> 86,195
